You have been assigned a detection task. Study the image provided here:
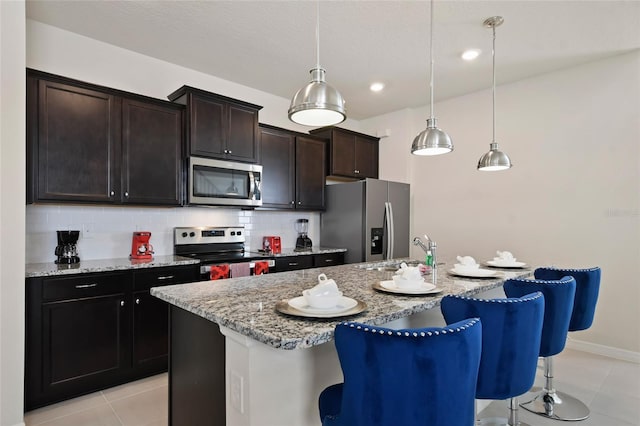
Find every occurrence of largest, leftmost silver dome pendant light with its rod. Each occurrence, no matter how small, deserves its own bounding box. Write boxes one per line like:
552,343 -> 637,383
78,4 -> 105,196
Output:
289,1 -> 347,127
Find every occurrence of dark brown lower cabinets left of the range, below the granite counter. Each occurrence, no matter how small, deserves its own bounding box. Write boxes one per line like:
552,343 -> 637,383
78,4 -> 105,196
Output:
25,265 -> 199,410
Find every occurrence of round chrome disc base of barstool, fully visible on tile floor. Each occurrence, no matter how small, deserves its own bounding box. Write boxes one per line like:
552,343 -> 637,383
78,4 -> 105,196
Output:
520,391 -> 590,422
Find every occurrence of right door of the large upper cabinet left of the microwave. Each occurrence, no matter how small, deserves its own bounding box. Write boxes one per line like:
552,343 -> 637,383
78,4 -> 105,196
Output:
122,99 -> 182,205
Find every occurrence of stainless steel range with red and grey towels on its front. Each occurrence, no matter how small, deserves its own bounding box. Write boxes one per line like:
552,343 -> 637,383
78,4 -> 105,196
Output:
173,226 -> 275,280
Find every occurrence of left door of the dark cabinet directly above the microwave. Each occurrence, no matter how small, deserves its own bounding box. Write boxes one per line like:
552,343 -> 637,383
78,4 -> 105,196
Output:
188,94 -> 227,158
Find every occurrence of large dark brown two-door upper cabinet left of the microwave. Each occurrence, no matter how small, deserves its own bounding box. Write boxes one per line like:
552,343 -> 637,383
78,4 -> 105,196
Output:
27,70 -> 184,205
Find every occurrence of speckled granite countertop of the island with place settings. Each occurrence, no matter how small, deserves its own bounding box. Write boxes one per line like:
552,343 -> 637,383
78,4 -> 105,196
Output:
151,262 -> 532,349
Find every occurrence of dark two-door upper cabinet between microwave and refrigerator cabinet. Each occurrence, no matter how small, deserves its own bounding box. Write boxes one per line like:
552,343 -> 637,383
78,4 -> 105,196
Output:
260,124 -> 327,210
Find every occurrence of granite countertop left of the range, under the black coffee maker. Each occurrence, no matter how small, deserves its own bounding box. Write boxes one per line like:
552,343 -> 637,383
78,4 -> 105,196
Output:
25,255 -> 200,278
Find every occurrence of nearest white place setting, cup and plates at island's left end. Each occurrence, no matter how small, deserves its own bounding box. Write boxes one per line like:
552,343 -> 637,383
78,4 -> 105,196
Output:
276,274 -> 367,318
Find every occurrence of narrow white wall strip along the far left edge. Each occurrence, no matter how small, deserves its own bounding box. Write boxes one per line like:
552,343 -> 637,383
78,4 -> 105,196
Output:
0,1 -> 26,426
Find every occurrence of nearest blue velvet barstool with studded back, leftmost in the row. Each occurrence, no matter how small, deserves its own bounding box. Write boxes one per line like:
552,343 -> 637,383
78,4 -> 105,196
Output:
319,318 -> 482,426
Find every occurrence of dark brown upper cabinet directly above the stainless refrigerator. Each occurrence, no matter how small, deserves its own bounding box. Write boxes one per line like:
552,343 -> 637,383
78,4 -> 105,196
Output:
310,127 -> 380,179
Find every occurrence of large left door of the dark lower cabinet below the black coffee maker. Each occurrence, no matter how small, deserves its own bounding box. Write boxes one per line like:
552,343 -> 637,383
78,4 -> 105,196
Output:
42,293 -> 130,400
